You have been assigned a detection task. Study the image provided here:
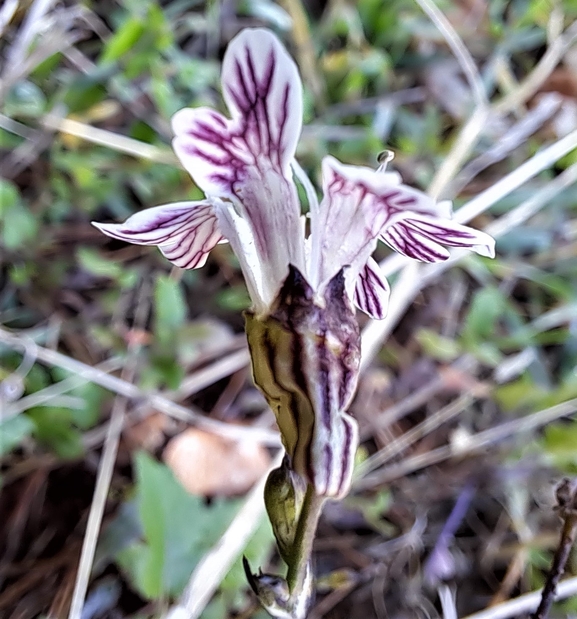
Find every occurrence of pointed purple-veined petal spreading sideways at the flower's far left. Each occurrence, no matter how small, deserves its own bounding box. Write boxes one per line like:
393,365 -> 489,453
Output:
92,202 -> 224,269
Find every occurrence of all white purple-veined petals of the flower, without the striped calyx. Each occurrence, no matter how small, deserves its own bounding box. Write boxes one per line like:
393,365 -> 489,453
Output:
94,28 -> 494,318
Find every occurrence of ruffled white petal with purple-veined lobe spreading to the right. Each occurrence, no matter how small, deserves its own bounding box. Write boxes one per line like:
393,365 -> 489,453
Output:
310,157 -> 494,284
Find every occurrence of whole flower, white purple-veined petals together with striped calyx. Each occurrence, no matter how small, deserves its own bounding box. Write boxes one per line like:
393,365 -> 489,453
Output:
94,28 -> 494,502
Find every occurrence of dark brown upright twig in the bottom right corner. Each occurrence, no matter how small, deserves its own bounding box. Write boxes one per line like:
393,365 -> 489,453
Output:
532,479 -> 577,619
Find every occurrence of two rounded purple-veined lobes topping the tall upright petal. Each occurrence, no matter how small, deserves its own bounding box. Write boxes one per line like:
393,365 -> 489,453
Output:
172,28 -> 302,197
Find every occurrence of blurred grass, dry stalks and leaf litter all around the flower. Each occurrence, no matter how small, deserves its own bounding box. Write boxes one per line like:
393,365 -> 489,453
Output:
0,0 -> 577,619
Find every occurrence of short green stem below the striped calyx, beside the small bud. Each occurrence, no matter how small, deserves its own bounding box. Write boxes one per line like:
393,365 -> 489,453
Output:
287,484 -> 325,600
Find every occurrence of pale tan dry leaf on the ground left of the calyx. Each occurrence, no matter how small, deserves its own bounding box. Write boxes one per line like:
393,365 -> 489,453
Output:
164,428 -> 270,496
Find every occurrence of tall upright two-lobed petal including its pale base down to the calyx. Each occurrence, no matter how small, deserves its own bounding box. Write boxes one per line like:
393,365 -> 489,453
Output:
172,28 -> 305,311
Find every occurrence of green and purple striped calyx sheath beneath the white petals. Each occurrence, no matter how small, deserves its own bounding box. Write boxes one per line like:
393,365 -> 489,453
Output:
246,266 -> 360,497
